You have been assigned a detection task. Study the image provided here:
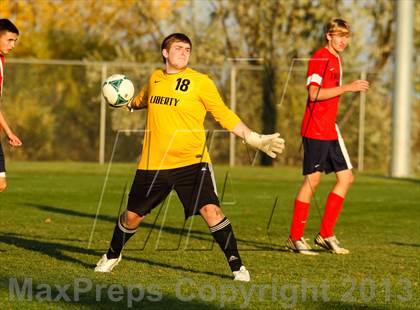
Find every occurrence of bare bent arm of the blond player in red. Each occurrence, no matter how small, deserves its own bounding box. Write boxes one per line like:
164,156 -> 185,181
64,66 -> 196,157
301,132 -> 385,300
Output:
308,80 -> 369,101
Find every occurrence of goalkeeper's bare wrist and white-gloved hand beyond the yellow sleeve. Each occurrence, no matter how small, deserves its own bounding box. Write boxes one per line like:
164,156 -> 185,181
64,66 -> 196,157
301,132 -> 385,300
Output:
231,121 -> 284,158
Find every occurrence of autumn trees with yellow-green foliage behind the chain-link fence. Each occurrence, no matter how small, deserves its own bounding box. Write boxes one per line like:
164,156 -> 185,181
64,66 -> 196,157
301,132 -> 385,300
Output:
0,0 -> 420,172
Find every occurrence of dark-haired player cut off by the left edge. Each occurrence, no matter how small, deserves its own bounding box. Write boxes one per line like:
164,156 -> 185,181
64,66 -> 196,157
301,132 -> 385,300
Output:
0,18 -> 22,192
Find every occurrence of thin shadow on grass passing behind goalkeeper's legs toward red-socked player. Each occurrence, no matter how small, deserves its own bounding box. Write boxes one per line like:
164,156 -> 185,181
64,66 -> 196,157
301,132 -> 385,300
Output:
25,203 -> 286,251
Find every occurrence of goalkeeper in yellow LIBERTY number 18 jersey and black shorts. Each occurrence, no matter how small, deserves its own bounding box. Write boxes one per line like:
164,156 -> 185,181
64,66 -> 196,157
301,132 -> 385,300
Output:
95,33 -> 284,282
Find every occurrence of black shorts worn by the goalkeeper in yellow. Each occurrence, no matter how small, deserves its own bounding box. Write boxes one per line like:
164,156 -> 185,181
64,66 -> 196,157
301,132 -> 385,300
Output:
127,163 -> 220,219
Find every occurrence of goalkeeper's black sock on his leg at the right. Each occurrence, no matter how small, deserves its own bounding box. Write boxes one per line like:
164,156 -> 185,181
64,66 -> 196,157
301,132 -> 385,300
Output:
210,217 -> 242,271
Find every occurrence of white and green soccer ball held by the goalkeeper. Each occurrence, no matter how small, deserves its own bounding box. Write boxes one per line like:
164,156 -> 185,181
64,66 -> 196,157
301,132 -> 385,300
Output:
102,74 -> 134,108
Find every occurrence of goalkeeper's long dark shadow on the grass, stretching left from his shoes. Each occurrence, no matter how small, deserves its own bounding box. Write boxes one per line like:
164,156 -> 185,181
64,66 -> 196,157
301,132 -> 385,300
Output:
0,233 -> 230,278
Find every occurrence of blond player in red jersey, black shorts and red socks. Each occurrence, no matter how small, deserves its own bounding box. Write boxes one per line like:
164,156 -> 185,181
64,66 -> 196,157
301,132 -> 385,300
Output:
286,19 -> 369,255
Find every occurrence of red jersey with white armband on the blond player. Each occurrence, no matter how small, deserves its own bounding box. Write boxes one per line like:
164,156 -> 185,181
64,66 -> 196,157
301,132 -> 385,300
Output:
301,47 -> 342,140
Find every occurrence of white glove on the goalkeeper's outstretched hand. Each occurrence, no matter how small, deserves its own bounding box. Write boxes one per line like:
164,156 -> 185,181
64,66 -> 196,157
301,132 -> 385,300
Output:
245,131 -> 284,158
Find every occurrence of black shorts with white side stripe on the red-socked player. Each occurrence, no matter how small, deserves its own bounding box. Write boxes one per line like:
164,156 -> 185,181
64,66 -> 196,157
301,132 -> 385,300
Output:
302,136 -> 353,175
